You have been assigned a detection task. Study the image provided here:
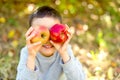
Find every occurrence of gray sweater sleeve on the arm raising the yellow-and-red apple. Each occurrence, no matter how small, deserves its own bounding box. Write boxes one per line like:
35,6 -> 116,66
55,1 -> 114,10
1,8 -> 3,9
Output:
16,47 -> 38,80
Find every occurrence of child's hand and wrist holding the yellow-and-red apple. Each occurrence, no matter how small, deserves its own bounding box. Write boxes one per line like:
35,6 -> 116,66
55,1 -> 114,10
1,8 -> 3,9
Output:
25,27 -> 41,57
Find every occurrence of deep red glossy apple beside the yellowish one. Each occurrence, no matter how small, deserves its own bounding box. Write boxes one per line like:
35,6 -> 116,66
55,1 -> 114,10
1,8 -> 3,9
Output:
50,24 -> 68,43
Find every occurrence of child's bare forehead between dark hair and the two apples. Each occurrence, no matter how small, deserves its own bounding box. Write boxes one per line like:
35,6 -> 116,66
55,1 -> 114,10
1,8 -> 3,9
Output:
32,17 -> 60,28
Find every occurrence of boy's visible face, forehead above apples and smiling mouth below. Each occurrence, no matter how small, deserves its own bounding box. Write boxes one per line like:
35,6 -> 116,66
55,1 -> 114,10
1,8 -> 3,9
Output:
32,17 -> 60,57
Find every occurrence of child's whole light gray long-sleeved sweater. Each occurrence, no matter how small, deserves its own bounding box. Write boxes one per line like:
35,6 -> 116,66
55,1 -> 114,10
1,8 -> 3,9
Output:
16,46 -> 85,80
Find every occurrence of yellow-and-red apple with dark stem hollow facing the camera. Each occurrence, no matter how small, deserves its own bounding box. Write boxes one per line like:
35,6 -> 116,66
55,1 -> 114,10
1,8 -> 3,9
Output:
31,26 -> 50,44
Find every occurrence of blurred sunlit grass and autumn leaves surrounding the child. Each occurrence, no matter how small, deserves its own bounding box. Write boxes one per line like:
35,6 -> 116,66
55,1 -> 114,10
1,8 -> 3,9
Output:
0,0 -> 120,80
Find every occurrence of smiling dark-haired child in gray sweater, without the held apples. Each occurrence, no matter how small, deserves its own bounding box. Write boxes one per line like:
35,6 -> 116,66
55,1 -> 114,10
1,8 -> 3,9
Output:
16,6 -> 85,80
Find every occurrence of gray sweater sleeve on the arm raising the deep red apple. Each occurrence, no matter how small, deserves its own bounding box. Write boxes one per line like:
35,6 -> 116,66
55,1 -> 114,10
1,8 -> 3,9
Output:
60,46 -> 86,80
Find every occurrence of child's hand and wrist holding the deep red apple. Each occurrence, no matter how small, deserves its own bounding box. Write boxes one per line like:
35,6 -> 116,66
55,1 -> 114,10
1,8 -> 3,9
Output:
50,25 -> 74,63
